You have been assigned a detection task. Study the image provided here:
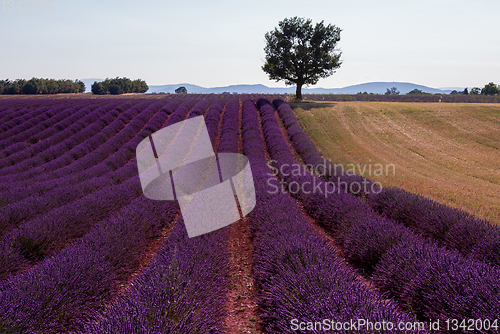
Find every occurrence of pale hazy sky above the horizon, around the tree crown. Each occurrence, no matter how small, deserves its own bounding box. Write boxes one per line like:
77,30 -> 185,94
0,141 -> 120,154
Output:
0,0 -> 500,88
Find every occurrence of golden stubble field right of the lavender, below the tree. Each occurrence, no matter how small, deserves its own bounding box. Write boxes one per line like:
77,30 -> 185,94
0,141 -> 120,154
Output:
291,102 -> 500,224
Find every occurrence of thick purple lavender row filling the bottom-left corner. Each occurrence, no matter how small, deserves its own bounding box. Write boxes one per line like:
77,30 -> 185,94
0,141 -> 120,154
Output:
0,196 -> 179,333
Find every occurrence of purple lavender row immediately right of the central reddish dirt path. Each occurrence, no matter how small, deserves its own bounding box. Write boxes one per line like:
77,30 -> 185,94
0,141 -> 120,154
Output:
242,101 -> 422,333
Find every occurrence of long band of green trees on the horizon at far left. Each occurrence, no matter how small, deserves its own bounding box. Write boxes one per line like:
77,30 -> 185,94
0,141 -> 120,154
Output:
0,78 -> 85,95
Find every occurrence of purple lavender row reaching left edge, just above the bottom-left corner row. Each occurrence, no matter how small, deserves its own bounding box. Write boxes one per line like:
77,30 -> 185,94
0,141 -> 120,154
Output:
0,98 -> 201,277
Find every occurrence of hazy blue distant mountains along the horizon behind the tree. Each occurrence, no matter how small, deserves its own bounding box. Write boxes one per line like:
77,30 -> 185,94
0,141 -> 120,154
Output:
82,79 -> 463,94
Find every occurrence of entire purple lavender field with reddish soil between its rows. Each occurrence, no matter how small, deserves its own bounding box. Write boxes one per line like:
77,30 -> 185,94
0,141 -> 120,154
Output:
0,95 -> 500,333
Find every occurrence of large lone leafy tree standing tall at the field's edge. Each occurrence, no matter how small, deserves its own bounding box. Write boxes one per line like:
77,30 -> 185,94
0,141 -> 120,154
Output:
262,16 -> 342,100
